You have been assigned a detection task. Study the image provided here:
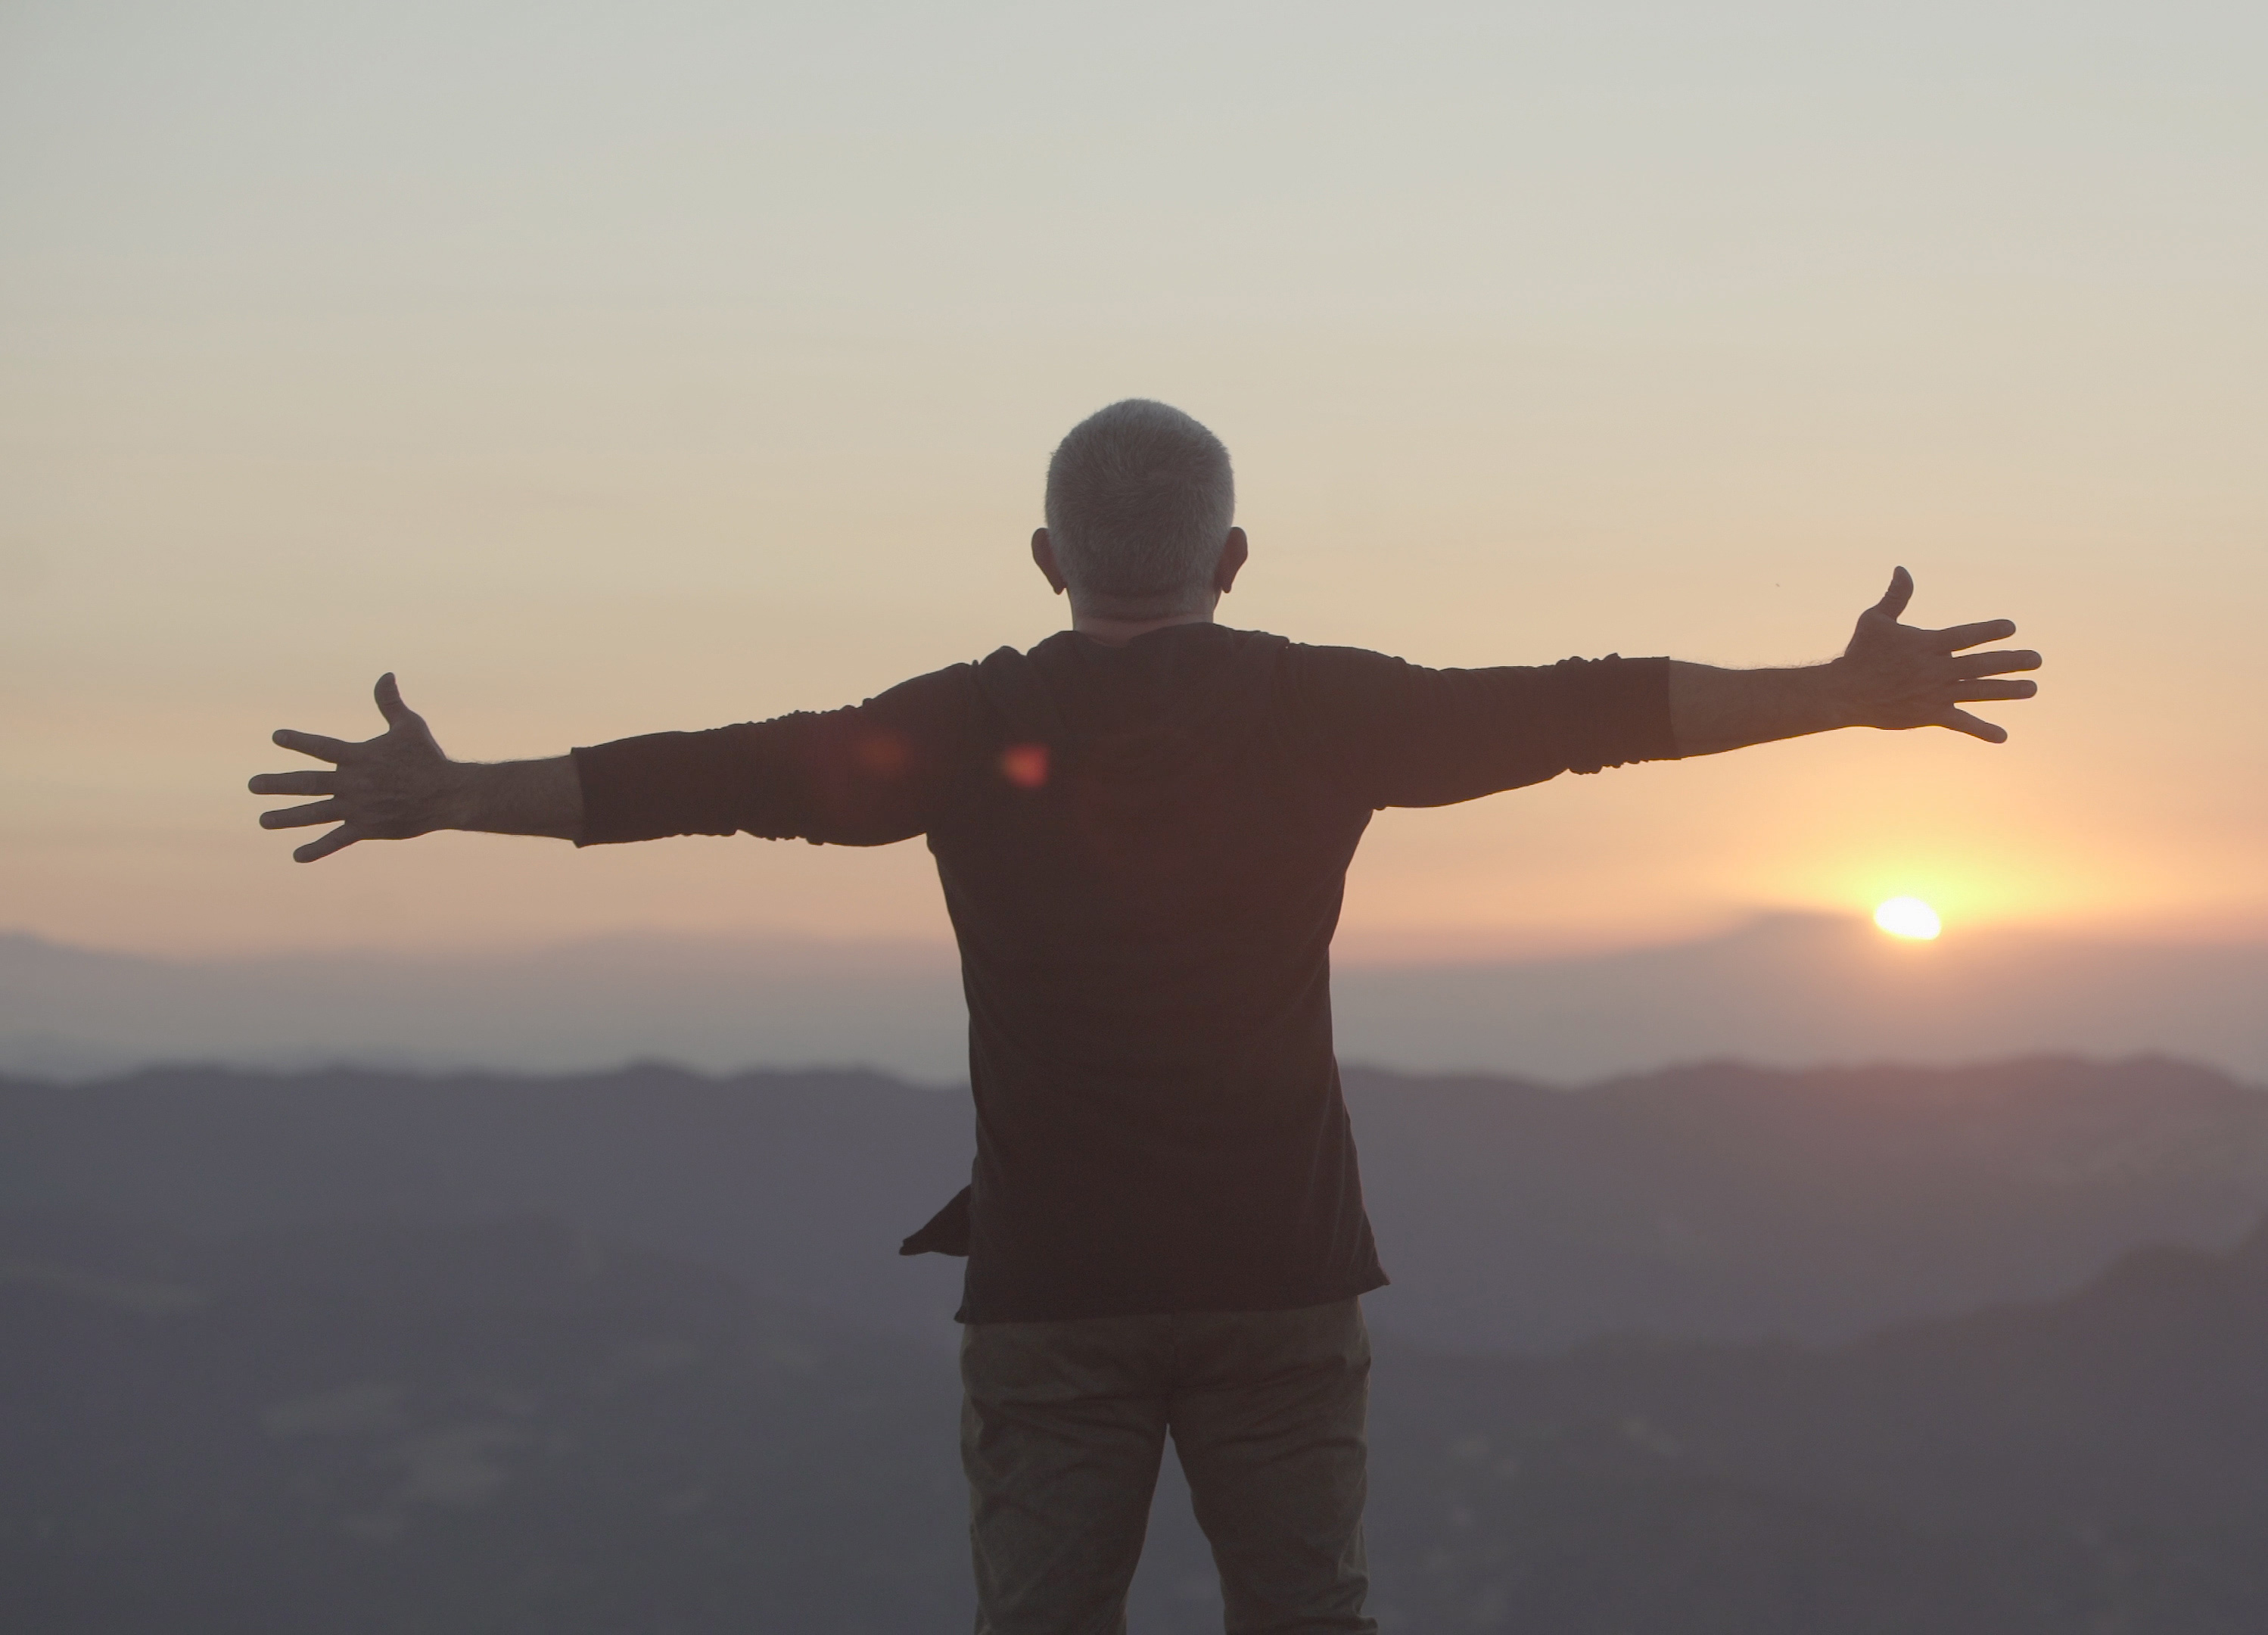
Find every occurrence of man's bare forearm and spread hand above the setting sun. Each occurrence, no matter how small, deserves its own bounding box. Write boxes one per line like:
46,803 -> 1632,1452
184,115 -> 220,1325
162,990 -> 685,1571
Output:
1669,567 -> 2039,755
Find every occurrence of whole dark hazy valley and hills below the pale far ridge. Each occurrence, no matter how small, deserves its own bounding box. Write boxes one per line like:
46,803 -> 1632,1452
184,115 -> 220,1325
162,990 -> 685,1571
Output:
0,1059 -> 2268,1635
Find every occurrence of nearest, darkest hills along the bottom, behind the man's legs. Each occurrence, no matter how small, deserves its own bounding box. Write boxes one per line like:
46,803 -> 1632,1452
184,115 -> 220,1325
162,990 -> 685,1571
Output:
13,1216 -> 2268,1635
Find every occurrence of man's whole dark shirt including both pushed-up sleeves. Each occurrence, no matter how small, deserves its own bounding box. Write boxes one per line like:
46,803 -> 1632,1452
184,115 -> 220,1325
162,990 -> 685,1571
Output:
576,624 -> 1676,1322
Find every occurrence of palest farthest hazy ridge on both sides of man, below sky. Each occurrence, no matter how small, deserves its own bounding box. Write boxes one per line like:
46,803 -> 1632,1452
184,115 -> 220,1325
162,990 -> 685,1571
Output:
0,916 -> 2268,1084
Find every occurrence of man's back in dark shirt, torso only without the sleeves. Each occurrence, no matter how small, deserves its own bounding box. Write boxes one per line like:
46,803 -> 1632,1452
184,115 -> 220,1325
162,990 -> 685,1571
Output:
930,626 -> 1386,1322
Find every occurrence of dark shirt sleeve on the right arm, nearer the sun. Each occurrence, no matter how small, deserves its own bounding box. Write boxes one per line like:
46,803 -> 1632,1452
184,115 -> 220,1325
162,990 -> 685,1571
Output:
1302,649 -> 1678,808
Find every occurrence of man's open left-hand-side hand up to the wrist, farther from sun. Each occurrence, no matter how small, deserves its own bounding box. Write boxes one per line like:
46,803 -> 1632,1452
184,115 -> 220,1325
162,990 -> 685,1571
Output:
250,674 -> 478,864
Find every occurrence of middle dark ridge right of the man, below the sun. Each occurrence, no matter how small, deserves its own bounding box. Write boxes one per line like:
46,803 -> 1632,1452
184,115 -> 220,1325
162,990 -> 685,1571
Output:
1349,1057 -> 2268,1350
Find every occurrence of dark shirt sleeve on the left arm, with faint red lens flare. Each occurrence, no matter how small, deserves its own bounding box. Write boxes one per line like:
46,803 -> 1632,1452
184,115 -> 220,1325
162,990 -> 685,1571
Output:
574,665 -> 975,846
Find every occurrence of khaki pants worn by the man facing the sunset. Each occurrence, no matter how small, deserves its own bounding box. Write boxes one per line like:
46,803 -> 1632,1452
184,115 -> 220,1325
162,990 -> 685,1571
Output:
962,1300 -> 1377,1635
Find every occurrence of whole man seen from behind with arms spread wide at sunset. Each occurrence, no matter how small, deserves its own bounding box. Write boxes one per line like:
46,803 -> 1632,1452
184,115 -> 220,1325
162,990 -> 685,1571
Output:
252,401 -> 2039,1635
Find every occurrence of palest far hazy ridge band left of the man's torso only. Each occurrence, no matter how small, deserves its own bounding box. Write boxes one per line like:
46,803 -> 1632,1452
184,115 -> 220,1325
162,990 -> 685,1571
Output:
0,934 -> 969,1084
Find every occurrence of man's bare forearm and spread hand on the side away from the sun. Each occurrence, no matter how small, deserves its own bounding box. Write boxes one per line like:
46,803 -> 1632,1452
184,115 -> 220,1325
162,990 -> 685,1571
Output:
252,674 -> 583,864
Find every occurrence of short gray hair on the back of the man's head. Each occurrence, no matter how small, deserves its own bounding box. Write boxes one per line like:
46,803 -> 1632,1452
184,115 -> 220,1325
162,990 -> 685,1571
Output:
1048,397 -> 1236,615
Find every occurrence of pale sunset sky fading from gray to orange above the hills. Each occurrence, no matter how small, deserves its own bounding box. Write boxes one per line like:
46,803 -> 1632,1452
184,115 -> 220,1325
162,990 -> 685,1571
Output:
0,0 -> 2268,961
